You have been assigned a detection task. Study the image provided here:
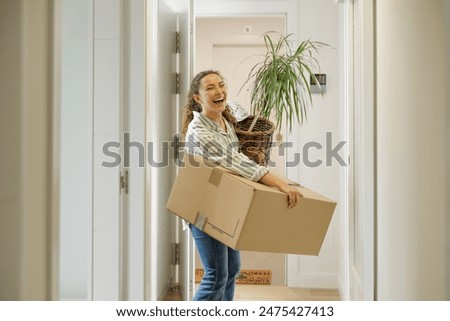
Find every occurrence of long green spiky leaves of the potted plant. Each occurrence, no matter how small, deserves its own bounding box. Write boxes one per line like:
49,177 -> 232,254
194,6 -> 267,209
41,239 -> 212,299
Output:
241,33 -> 327,131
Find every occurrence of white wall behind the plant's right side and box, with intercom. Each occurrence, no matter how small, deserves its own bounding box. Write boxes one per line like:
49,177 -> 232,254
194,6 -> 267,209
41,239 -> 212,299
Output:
287,0 -> 344,288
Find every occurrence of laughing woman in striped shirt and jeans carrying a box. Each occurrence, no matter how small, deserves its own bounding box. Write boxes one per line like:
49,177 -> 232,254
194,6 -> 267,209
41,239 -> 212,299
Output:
183,70 -> 301,301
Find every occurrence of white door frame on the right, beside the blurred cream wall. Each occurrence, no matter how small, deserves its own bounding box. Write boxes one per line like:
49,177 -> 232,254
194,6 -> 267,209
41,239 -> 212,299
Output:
341,0 -> 376,300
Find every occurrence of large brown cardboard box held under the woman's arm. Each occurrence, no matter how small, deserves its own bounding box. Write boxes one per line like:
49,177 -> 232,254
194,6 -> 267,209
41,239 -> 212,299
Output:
167,156 -> 336,255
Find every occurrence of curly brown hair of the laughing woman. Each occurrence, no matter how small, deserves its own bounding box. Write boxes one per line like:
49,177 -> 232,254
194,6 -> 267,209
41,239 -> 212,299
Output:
182,70 -> 236,134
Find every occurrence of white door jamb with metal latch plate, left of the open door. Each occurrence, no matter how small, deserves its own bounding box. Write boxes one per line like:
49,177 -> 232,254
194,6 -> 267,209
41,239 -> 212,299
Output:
92,0 -> 147,300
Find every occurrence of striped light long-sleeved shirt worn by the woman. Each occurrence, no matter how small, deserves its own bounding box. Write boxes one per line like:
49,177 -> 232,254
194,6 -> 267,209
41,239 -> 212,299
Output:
184,111 -> 269,181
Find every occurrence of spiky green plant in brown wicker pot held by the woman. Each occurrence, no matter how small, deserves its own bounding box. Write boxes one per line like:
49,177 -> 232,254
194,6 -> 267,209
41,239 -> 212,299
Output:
236,33 -> 326,164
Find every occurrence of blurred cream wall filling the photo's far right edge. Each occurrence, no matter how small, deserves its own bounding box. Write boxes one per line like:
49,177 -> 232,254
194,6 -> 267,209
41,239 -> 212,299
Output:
376,0 -> 449,300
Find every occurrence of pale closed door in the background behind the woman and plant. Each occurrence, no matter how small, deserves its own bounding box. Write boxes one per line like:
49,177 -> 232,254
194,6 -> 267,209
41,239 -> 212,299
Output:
194,15 -> 286,285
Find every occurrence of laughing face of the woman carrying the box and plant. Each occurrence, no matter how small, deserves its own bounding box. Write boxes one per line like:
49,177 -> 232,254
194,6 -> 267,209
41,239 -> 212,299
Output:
194,74 -> 227,114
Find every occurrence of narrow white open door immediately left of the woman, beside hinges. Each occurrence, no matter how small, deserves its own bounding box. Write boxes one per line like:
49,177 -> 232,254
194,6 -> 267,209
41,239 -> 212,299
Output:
145,0 -> 181,300
